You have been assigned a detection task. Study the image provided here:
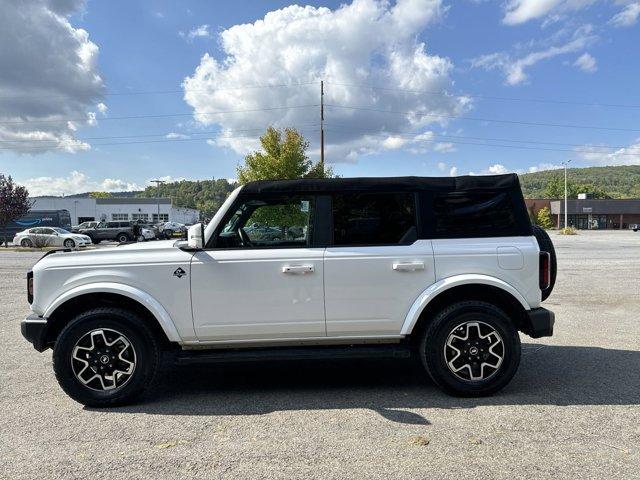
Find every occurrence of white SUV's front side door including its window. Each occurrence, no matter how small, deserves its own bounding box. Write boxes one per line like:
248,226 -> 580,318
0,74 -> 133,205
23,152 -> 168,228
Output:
191,195 -> 326,342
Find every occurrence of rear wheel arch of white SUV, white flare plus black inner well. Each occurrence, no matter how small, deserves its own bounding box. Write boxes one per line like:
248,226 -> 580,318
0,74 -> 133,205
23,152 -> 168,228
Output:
400,274 -> 530,336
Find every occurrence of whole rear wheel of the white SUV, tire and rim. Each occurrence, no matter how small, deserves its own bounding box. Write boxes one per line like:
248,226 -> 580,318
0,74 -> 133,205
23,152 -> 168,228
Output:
420,301 -> 520,397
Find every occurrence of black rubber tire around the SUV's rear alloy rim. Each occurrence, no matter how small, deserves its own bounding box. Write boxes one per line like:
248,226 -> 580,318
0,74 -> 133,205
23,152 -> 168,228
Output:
420,301 -> 520,397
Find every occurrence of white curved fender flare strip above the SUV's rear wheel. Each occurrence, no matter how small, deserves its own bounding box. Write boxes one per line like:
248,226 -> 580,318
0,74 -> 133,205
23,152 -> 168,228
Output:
400,274 -> 531,335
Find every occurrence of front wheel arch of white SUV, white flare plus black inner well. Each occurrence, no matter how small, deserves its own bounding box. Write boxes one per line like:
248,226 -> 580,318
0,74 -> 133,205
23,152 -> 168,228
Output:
43,283 -> 180,345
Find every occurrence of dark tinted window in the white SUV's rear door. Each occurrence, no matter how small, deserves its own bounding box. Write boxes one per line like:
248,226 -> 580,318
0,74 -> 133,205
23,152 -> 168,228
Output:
332,193 -> 417,246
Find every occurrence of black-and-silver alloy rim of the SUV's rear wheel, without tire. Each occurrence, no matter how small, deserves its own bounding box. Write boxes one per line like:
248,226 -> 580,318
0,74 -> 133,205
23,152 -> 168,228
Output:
444,321 -> 505,382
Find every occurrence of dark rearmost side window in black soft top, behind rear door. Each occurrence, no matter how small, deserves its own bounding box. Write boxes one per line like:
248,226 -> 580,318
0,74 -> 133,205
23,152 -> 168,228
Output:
433,192 -> 520,238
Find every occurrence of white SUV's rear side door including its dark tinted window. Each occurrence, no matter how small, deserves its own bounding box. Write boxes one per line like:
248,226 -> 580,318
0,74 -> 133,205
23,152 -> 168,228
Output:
324,192 -> 435,336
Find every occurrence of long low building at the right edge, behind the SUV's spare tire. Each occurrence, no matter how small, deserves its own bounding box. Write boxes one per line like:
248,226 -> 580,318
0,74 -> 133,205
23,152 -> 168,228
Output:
525,198 -> 640,230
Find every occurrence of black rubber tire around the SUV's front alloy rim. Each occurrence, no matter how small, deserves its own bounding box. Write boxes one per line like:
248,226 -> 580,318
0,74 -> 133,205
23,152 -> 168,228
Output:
53,308 -> 161,407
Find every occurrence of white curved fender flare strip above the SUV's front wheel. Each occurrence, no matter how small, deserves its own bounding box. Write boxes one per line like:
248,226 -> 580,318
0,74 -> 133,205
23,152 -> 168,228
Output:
42,282 -> 181,342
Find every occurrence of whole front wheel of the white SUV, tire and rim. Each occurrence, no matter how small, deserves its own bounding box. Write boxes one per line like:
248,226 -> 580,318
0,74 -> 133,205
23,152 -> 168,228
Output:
53,308 -> 161,407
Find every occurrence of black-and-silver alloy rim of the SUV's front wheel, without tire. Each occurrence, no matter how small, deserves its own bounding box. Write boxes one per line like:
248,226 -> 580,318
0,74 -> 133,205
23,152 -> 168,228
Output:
71,328 -> 136,391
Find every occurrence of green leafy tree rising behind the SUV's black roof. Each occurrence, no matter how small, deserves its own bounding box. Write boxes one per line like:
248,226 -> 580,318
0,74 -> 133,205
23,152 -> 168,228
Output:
238,127 -> 333,185
